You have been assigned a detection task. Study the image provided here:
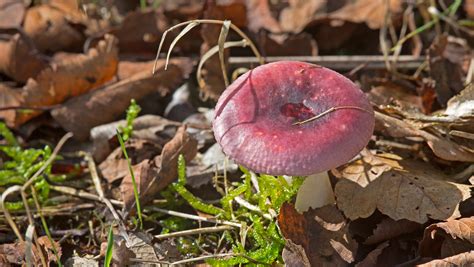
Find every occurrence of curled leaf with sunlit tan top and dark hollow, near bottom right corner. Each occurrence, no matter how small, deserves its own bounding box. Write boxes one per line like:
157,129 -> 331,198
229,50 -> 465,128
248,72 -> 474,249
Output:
420,217 -> 474,258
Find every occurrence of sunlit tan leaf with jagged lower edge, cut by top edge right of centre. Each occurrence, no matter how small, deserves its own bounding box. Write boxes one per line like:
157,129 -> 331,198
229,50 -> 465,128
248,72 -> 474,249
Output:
328,0 -> 402,29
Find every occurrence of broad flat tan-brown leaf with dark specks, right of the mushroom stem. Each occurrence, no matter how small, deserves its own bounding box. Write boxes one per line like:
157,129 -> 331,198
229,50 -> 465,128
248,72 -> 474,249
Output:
333,154 -> 471,223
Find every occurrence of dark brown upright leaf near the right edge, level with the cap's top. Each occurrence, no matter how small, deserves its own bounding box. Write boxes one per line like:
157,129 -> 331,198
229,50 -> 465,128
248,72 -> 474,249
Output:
428,35 -> 470,107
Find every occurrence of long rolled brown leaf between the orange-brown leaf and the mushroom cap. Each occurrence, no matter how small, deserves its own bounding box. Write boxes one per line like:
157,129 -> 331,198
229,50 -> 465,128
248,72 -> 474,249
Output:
51,59 -> 192,139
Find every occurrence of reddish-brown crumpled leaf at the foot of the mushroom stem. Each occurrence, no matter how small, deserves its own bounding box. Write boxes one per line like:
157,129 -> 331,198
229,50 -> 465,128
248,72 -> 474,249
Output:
278,203 -> 357,266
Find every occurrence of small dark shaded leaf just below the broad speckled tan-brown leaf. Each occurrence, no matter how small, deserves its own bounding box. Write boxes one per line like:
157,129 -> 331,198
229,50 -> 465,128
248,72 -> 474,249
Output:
364,218 -> 420,245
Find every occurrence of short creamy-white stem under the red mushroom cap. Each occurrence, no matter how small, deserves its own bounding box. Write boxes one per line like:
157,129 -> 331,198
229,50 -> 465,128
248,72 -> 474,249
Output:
295,172 -> 336,213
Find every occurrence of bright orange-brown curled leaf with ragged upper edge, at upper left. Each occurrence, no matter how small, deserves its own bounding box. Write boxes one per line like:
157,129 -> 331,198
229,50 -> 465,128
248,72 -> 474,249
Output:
10,35 -> 118,126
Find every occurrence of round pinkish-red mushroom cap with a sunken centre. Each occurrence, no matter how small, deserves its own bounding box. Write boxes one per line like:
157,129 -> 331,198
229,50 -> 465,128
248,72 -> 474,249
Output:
213,61 -> 374,175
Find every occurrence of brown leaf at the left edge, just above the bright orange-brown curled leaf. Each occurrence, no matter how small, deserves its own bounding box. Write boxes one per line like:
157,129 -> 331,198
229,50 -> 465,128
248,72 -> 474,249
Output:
0,33 -> 48,83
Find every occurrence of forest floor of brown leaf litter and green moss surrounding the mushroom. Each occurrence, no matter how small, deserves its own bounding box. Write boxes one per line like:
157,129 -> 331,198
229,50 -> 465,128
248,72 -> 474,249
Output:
0,0 -> 474,266
